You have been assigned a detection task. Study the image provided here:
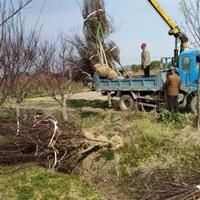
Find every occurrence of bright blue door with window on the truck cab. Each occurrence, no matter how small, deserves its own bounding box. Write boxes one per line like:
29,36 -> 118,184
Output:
179,55 -> 194,86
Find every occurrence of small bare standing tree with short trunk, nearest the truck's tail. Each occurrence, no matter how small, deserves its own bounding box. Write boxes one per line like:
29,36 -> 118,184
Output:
39,36 -> 78,121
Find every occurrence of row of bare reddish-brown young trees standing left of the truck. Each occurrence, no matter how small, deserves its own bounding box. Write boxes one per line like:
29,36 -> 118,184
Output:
0,0 -> 81,127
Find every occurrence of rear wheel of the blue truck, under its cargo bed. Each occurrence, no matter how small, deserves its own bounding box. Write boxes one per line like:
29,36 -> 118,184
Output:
119,95 -> 135,111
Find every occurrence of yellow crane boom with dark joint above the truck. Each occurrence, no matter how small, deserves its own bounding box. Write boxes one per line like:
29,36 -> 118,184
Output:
148,0 -> 188,66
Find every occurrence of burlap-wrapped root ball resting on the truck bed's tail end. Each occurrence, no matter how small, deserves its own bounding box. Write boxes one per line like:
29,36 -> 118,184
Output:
94,63 -> 118,79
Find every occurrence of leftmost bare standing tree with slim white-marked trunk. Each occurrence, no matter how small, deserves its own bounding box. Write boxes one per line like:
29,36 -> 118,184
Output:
0,15 -> 40,133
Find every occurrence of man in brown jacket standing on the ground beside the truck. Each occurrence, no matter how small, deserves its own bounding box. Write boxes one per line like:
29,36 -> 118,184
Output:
165,68 -> 181,113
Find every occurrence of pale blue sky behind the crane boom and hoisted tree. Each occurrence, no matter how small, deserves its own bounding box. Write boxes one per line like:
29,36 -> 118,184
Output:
18,0 -> 184,65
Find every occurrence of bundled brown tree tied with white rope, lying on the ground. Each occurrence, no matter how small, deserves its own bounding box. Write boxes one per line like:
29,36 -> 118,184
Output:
0,113 -> 111,172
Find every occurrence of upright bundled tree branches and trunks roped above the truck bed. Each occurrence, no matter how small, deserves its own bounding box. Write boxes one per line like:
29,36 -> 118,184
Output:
71,0 -> 120,79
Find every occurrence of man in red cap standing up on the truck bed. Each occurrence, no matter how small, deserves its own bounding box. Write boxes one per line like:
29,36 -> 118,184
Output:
140,43 -> 151,77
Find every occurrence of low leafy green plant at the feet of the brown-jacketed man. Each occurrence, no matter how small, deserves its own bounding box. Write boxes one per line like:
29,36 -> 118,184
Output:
157,109 -> 189,128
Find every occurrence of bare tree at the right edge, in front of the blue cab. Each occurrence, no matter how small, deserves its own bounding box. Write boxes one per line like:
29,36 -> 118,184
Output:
181,0 -> 200,130
